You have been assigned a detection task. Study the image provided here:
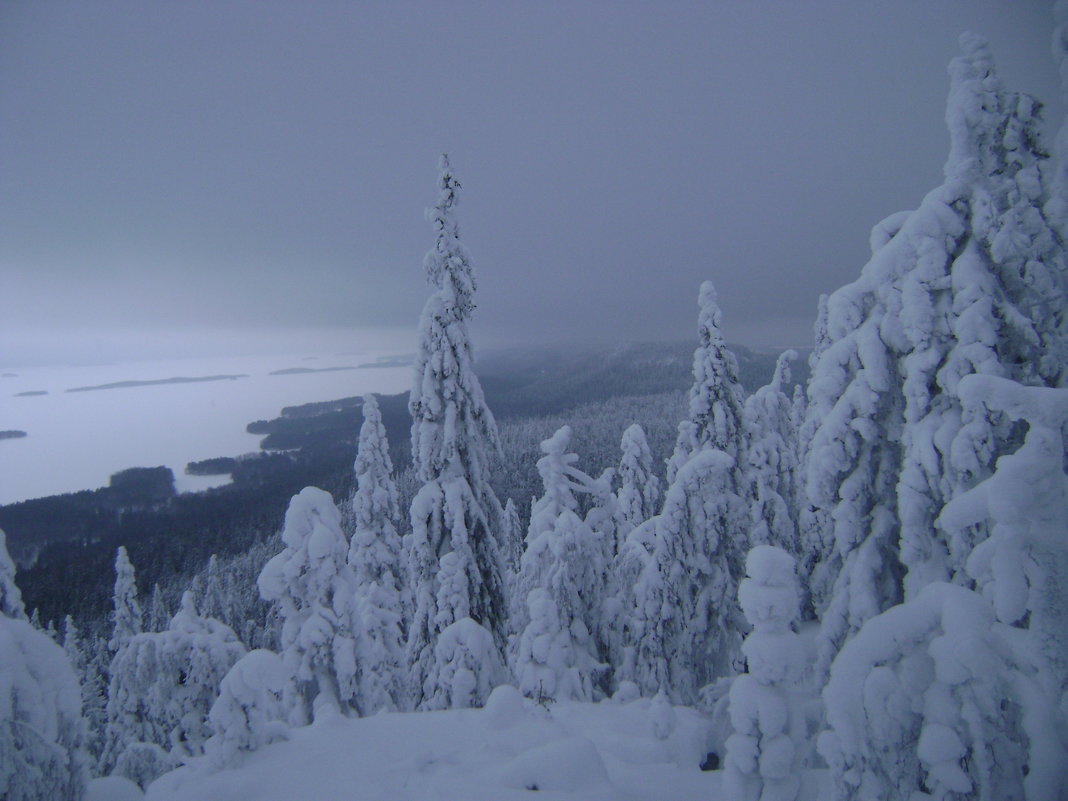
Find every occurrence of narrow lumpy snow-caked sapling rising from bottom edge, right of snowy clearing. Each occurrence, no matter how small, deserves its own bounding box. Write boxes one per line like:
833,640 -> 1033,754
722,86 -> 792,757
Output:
723,545 -> 805,801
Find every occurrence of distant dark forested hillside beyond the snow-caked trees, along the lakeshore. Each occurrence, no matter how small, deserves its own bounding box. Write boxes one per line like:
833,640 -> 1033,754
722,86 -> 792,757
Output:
0,343 -> 804,628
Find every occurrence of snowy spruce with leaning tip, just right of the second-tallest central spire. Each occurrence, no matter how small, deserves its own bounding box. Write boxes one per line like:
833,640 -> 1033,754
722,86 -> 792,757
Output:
745,350 -> 800,553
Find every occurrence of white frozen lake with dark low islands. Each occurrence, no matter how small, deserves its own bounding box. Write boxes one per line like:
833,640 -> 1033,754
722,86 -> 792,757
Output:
0,352 -> 411,504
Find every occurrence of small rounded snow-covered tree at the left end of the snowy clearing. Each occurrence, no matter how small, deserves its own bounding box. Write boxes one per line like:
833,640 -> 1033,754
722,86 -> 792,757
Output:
204,648 -> 289,768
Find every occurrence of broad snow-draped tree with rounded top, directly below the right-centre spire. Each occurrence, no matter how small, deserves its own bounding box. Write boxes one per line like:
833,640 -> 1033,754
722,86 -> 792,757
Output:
633,449 -> 745,704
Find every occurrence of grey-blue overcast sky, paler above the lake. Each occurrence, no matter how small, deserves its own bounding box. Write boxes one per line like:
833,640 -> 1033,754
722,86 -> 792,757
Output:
0,0 -> 1065,362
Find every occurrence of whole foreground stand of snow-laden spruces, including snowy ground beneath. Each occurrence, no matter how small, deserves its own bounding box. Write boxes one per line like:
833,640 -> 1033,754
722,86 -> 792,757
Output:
6,25 -> 1068,801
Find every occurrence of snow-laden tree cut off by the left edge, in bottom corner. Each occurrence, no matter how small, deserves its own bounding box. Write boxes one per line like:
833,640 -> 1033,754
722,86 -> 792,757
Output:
0,531 -> 89,801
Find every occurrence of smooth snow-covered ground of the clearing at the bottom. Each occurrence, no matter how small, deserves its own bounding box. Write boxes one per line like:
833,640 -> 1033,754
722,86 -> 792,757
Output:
137,687 -> 817,801
